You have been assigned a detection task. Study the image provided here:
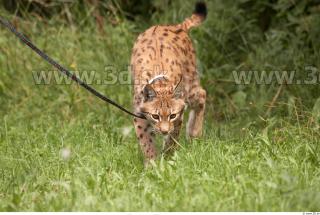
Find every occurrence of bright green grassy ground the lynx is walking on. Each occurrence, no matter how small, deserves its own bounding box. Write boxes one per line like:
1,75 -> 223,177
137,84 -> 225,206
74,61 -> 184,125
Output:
0,0 -> 320,211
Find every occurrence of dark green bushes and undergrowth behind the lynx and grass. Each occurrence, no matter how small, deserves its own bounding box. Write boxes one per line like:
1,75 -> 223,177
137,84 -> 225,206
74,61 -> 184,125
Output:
2,0 -> 320,124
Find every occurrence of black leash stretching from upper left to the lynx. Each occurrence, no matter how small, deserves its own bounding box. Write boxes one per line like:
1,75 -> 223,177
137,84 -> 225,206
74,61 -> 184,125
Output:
0,16 -> 146,119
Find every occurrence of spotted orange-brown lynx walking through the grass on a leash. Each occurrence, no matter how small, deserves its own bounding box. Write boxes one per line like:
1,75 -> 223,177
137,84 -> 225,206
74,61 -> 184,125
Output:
131,2 -> 207,163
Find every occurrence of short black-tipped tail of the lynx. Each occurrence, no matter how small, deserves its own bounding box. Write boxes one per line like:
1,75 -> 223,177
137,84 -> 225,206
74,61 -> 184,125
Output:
180,2 -> 207,31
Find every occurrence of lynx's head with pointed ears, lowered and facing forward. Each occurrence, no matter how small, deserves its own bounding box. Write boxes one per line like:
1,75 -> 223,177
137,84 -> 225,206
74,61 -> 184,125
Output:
140,77 -> 186,135
